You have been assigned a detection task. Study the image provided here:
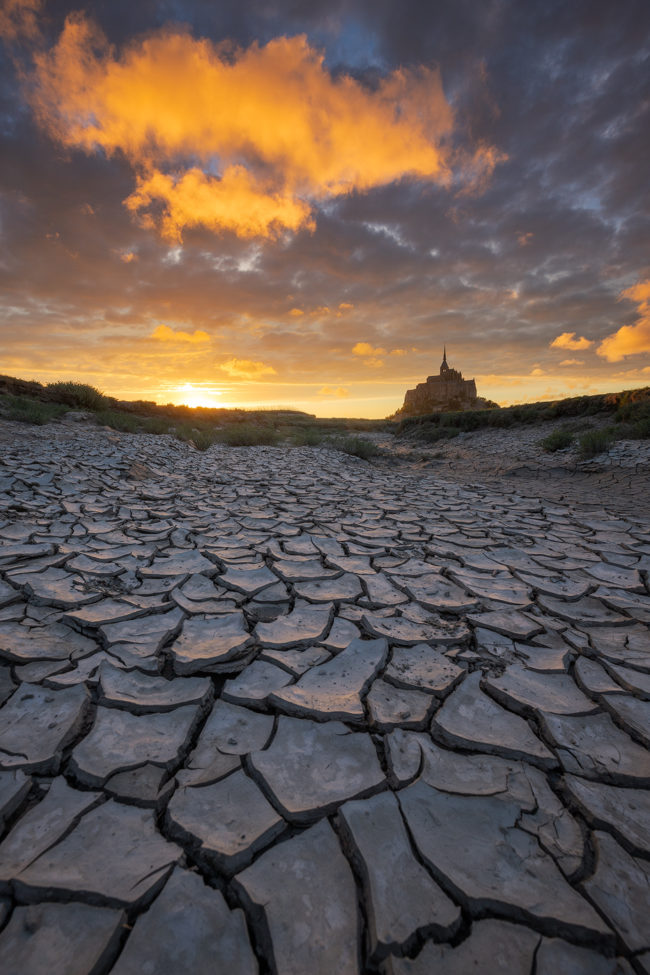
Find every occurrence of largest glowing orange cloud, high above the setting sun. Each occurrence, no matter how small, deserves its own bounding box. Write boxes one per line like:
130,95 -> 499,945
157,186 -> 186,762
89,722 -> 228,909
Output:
30,20 -> 458,240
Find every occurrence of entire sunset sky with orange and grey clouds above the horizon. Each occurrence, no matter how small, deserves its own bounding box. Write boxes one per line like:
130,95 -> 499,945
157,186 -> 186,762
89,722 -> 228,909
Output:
0,0 -> 650,417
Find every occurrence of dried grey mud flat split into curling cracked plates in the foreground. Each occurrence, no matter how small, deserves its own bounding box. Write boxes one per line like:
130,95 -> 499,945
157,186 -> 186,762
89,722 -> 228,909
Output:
0,424 -> 650,975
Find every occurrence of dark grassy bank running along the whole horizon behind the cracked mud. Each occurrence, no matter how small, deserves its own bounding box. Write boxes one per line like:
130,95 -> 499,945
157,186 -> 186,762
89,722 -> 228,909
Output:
0,376 -> 650,459
